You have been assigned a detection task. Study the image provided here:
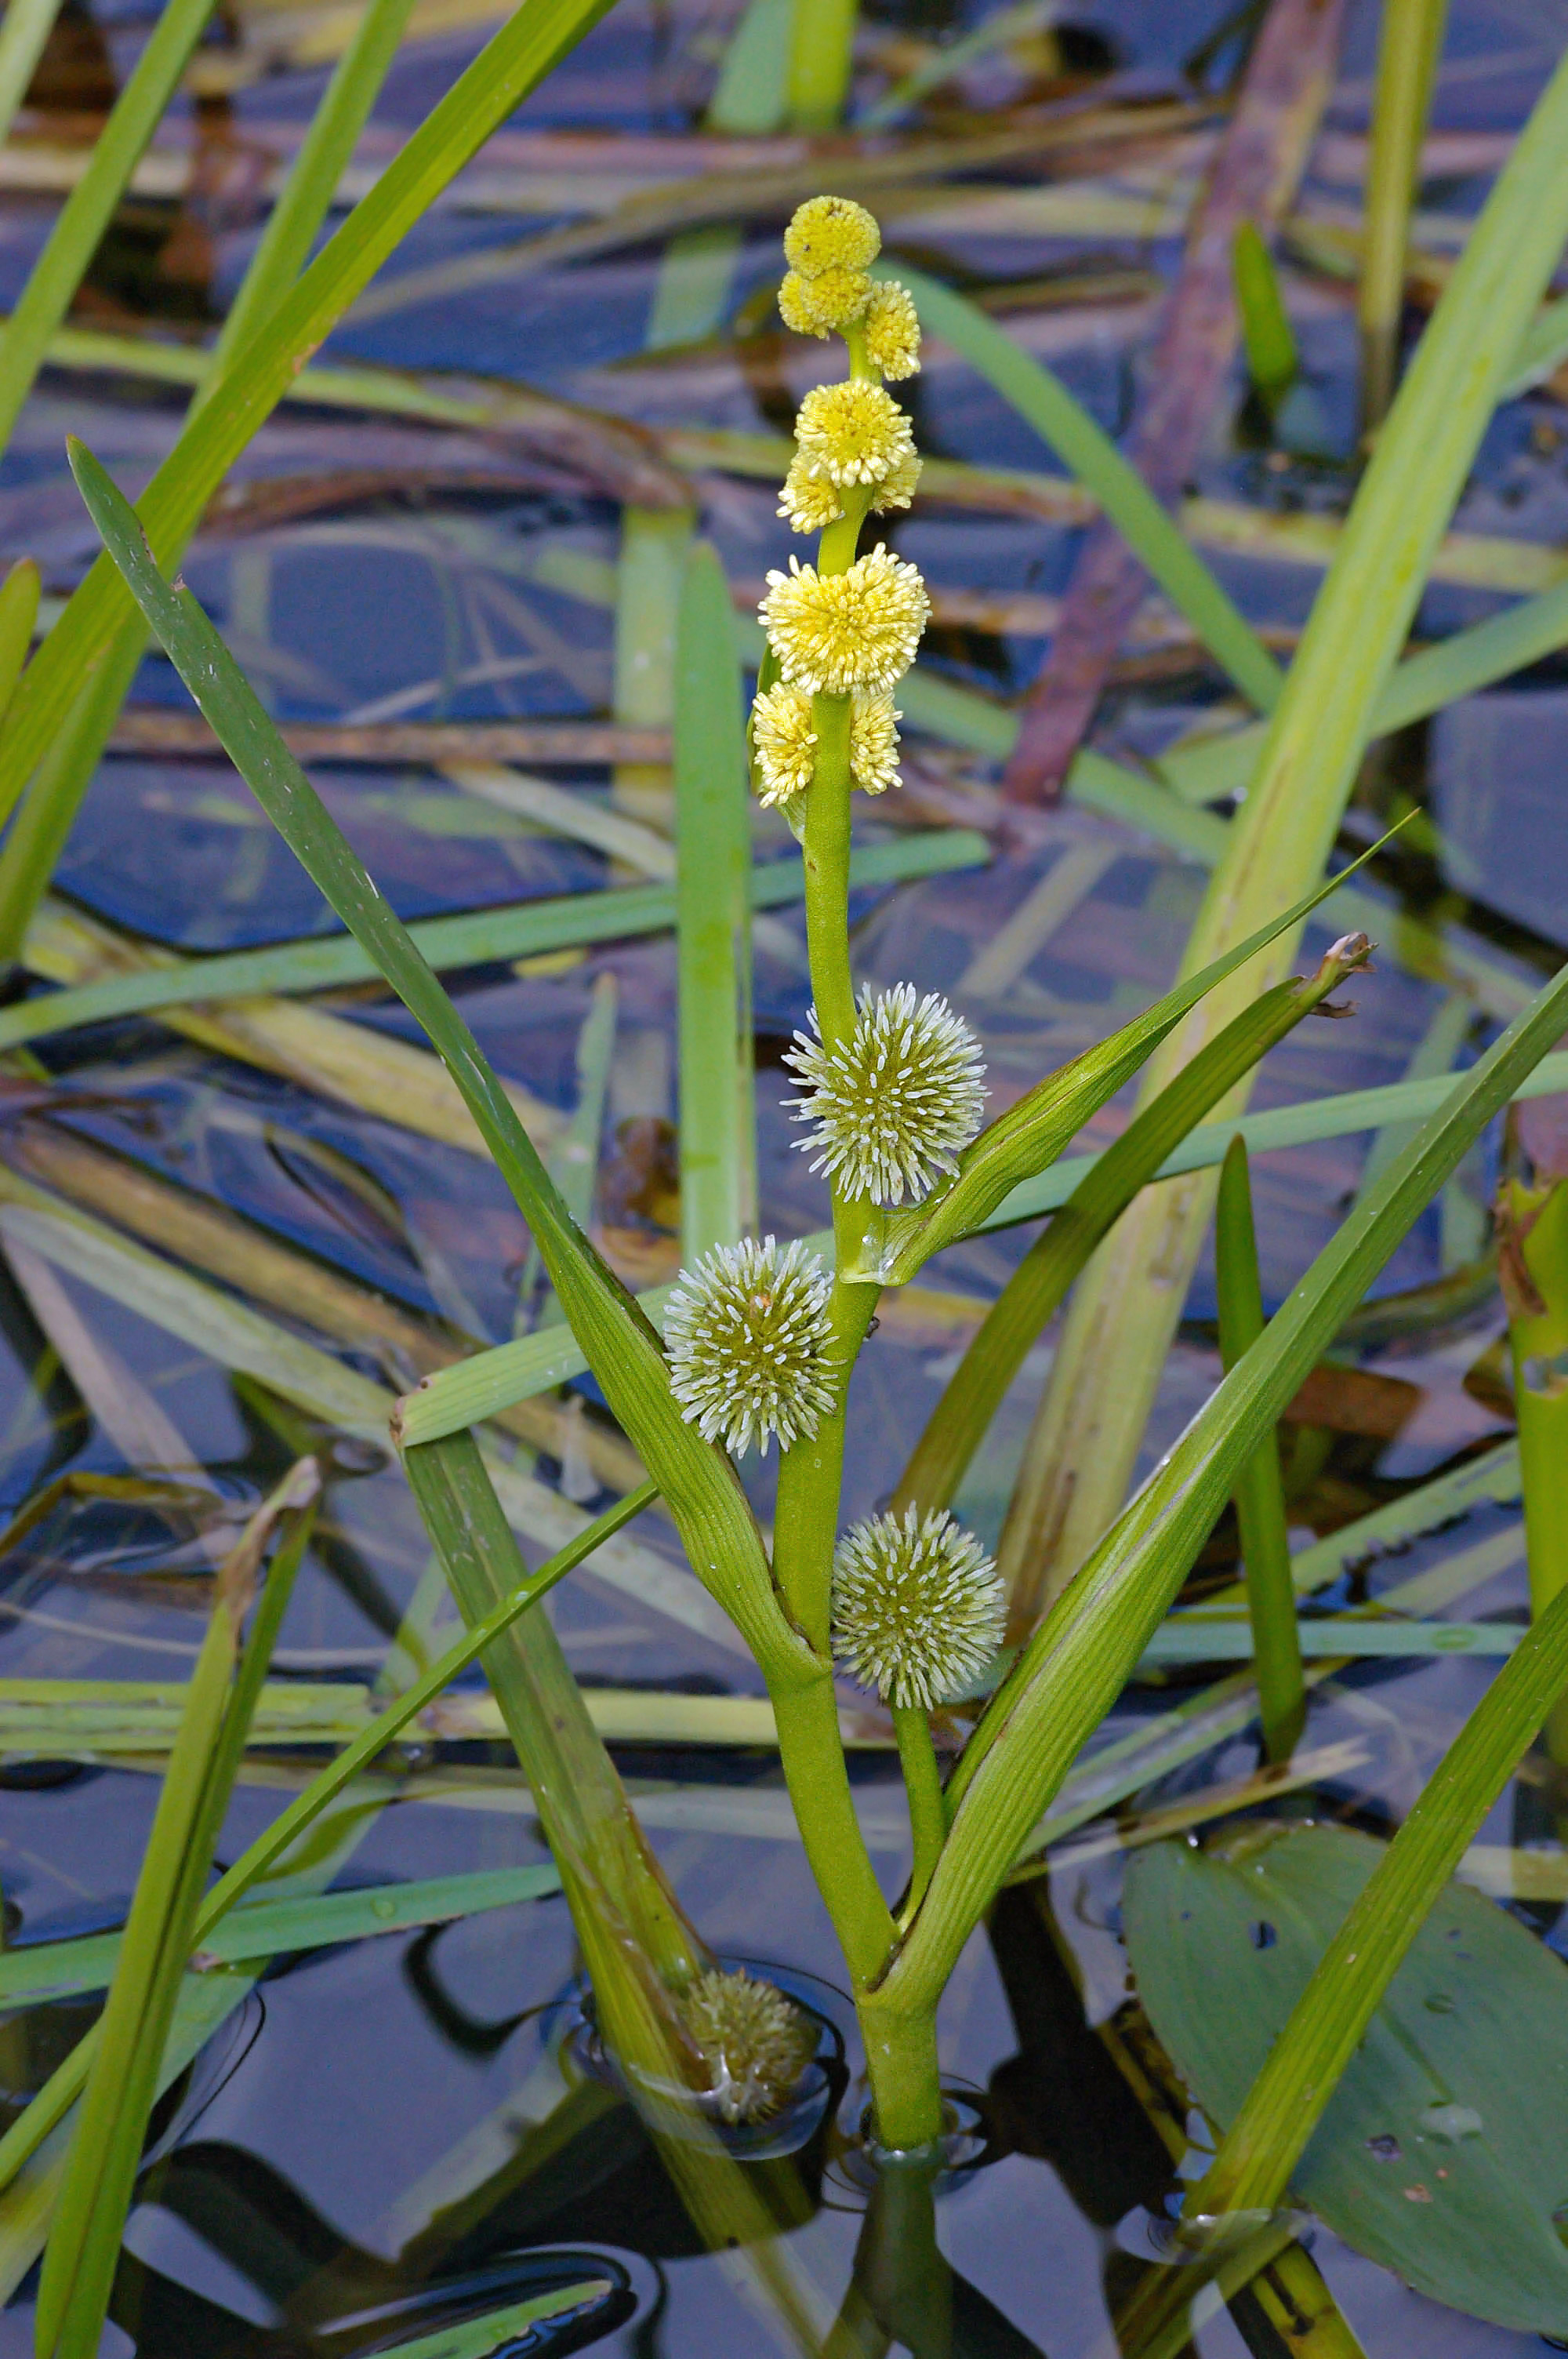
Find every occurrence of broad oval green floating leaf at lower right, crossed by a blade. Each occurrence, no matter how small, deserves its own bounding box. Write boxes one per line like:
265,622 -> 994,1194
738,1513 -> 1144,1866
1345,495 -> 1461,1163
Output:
1123,1821 -> 1568,2335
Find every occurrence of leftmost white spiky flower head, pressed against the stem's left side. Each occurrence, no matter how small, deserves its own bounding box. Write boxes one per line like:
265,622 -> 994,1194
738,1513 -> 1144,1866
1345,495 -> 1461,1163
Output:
665,1236 -> 833,1458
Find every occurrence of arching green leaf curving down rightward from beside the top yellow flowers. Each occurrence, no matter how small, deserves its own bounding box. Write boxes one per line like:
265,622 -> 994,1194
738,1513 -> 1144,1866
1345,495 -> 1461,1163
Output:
880,262 -> 1280,712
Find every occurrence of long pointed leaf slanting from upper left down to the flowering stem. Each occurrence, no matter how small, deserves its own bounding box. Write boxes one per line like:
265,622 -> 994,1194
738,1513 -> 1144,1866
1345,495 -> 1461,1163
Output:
71,444 -> 816,1685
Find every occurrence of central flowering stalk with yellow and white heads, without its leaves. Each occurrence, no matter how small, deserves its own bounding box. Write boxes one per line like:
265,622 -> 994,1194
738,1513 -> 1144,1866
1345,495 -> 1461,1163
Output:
702,196 -> 1000,2146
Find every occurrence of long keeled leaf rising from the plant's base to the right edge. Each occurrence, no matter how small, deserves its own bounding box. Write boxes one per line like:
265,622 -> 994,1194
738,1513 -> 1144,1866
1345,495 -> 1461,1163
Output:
884,934 -> 1568,2005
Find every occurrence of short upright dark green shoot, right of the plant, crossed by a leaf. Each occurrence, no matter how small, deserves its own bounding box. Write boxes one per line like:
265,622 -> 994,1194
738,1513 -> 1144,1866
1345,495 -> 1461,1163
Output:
1214,1137 -> 1306,1762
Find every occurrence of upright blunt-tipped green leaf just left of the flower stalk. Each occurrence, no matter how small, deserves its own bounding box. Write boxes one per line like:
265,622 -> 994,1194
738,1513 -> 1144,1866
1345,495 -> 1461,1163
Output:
674,540 -> 757,1267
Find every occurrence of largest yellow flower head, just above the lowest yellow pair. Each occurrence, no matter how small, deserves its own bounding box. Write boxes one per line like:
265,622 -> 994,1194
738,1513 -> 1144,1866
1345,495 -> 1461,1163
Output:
761,543 -> 931,696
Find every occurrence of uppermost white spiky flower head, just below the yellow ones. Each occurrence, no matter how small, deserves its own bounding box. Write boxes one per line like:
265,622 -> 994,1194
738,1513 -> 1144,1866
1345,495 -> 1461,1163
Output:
786,983 -> 985,1205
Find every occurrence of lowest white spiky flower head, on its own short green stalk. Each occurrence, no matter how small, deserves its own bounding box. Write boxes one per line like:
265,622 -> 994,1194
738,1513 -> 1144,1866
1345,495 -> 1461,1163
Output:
833,1507 -> 1004,1710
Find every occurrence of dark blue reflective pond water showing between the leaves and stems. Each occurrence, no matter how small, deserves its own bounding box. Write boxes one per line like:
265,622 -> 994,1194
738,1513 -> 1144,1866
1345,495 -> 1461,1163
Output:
0,0 -> 1568,2359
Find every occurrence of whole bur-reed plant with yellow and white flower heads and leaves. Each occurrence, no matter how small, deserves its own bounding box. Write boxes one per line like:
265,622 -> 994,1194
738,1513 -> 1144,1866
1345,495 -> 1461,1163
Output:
73,171 -> 1568,2208
